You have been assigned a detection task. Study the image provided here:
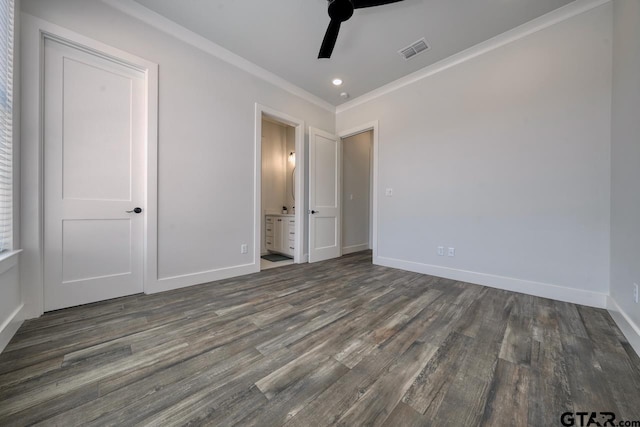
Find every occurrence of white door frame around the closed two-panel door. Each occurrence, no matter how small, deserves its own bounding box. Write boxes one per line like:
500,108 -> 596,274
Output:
20,13 -> 158,318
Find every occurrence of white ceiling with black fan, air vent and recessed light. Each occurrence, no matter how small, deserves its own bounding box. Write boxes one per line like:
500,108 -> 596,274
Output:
136,0 -> 572,105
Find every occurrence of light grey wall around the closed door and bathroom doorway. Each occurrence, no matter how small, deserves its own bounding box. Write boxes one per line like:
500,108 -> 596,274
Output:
22,0 -> 335,315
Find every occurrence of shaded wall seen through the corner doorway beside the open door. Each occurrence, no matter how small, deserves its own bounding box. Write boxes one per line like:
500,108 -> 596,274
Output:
342,131 -> 373,254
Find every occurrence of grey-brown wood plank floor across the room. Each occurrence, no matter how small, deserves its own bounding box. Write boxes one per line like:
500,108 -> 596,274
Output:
0,252 -> 640,427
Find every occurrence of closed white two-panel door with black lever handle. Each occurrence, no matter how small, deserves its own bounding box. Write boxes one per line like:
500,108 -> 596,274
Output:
44,39 -> 147,311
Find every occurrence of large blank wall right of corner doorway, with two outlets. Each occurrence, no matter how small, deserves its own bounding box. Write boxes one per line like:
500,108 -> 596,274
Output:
337,3 -> 612,306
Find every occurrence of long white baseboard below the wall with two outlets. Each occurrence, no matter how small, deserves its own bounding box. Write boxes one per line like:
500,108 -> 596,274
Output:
373,256 -> 607,308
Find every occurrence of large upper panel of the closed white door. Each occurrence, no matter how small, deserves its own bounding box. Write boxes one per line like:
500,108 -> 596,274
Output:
62,57 -> 132,201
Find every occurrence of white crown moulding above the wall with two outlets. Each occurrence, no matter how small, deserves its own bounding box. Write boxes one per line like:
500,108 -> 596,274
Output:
336,0 -> 612,114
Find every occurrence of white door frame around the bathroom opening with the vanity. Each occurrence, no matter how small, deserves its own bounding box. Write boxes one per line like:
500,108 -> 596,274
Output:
253,102 -> 307,271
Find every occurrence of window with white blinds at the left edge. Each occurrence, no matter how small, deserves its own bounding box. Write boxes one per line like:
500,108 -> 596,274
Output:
0,0 -> 14,252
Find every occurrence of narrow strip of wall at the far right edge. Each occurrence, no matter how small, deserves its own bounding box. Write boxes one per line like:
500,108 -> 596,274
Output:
611,0 -> 640,352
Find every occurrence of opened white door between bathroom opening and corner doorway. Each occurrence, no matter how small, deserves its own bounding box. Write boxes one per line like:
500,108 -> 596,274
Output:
309,128 -> 342,262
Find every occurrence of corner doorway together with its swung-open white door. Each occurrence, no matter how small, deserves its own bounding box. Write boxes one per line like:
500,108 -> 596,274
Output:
308,121 -> 378,262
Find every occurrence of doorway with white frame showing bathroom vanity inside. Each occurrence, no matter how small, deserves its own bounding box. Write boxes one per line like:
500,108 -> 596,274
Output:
255,104 -> 304,270
